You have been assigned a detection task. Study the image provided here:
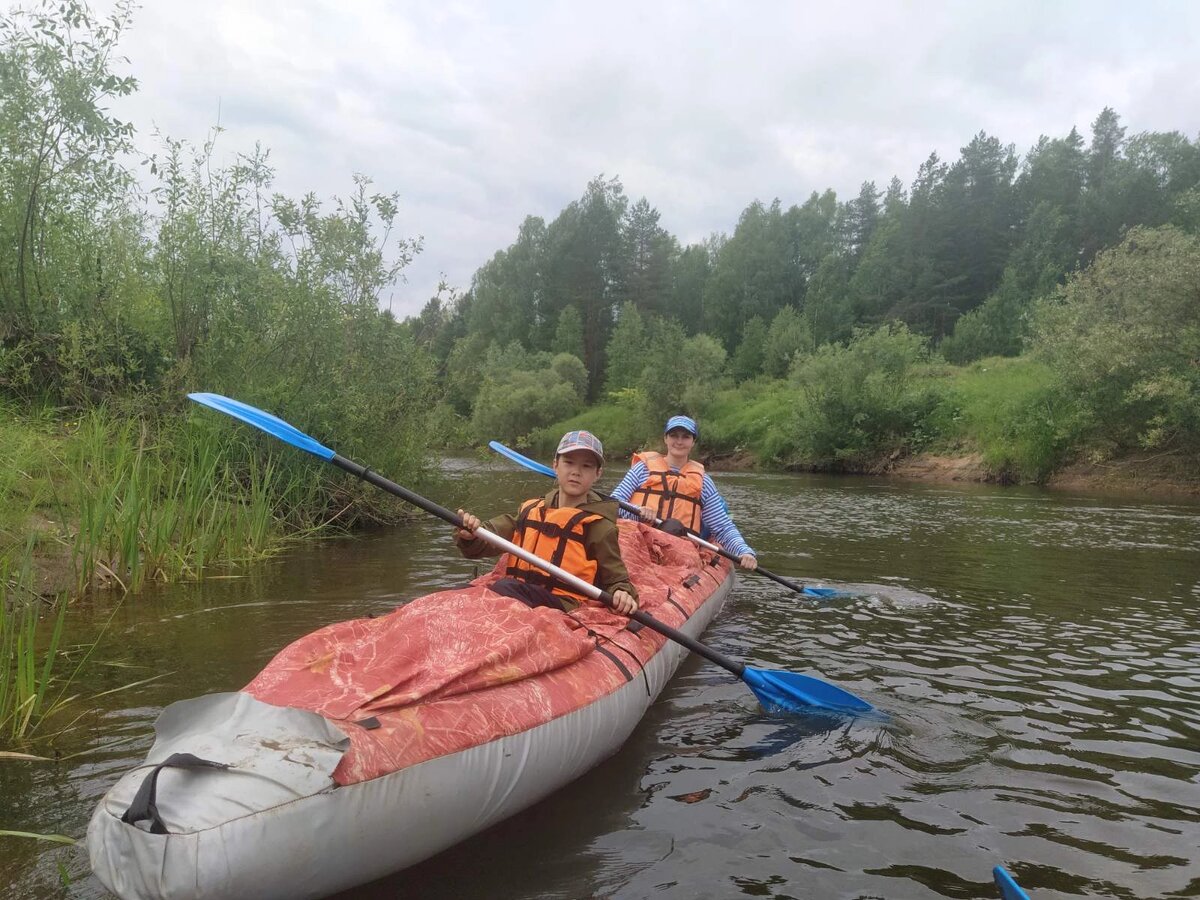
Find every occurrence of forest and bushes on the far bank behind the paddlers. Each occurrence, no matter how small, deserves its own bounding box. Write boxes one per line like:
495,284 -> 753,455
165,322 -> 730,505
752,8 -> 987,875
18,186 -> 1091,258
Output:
413,108 -> 1200,480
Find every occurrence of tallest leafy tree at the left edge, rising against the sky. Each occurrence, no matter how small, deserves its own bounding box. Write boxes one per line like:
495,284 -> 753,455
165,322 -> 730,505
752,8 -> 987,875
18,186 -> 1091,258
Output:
0,0 -> 137,341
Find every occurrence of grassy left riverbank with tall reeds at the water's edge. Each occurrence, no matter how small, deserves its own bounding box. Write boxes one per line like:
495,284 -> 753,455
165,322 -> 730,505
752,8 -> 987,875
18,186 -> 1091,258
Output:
0,407 -> 421,748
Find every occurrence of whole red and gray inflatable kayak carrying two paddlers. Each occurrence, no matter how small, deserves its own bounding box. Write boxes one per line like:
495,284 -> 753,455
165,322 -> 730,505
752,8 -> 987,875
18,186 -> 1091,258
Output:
86,522 -> 733,900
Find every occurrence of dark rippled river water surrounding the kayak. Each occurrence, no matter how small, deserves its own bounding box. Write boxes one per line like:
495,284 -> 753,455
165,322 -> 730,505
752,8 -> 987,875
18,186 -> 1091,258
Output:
0,461 -> 1200,900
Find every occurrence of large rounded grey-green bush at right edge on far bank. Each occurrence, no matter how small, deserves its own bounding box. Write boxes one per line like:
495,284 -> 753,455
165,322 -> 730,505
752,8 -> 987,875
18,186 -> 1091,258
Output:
1034,227 -> 1200,451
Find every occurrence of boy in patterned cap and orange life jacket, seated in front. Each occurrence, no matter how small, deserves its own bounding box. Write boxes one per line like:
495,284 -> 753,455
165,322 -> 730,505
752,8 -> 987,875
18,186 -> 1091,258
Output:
454,431 -> 637,616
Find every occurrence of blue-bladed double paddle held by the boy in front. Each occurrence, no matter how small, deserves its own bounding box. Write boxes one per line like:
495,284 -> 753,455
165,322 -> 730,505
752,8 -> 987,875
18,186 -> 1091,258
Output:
187,394 -> 874,713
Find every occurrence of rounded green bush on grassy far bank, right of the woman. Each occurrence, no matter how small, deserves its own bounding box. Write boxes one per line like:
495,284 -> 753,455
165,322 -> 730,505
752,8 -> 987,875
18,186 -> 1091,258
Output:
791,325 -> 936,468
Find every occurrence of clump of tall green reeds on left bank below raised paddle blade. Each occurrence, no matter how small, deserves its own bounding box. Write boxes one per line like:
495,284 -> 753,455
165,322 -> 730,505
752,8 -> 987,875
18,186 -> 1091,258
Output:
66,409 -> 317,590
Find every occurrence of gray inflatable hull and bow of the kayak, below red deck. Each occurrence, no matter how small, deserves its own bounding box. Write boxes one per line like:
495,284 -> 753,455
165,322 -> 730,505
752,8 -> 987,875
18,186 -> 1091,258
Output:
86,572 -> 734,900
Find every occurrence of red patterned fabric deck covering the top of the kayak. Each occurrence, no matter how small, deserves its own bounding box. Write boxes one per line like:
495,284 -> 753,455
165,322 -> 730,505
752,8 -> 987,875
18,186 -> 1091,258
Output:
245,521 -> 730,785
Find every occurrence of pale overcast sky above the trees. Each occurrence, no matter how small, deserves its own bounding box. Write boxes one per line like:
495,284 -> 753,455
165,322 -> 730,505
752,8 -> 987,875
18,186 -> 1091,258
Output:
97,0 -> 1200,317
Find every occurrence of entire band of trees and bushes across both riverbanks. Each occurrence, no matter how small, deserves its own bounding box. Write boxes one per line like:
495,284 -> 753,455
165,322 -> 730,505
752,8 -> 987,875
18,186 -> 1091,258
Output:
0,0 -> 1200,600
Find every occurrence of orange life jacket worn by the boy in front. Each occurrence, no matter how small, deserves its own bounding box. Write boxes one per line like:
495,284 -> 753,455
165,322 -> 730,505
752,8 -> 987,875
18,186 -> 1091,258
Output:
504,497 -> 604,604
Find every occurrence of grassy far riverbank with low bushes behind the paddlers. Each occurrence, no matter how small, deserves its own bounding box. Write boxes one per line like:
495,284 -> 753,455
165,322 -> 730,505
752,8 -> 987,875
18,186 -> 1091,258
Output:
516,358 -> 1200,496
